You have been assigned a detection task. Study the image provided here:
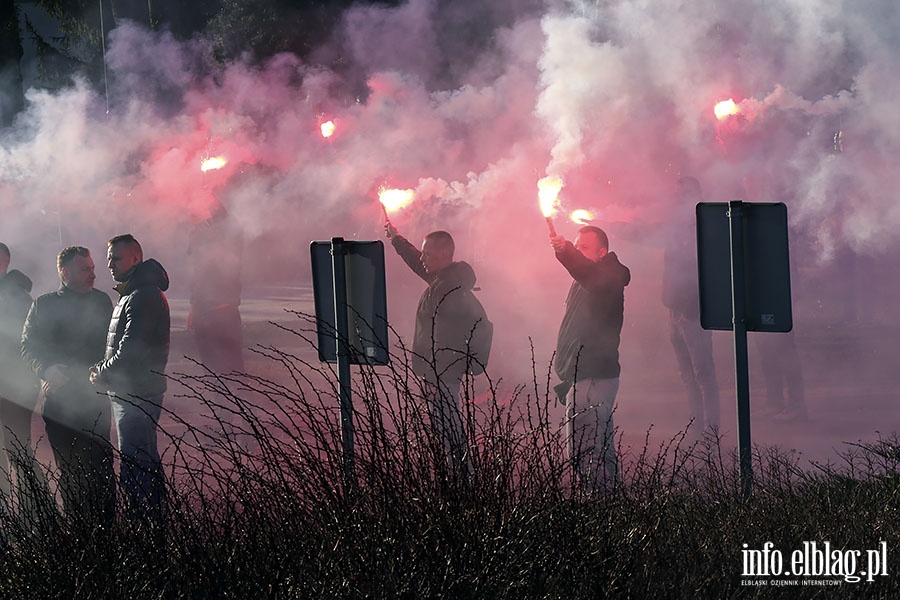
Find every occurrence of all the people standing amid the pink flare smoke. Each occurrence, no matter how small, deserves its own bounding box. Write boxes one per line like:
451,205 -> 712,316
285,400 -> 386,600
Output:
0,172 -> 806,525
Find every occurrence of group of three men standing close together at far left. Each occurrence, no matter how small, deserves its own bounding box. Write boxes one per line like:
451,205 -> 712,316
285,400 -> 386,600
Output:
0,234 -> 170,526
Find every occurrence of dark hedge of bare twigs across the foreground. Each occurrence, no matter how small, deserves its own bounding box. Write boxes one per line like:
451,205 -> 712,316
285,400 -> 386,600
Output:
0,319 -> 900,599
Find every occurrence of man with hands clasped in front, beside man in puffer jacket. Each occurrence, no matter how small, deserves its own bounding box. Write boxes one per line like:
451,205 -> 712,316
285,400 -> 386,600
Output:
22,246 -> 115,524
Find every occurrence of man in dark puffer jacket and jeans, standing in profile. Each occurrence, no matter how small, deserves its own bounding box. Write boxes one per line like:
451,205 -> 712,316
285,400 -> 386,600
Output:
91,234 -> 169,520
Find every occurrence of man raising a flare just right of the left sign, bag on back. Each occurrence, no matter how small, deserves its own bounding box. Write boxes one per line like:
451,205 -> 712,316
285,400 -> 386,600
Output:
385,222 -> 489,472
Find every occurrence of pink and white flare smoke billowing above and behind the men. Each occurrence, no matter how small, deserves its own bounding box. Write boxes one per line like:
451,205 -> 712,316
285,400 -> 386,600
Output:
0,0 -> 900,450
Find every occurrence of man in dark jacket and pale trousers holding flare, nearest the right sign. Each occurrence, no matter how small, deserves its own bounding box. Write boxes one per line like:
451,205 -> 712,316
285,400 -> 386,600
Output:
550,225 -> 631,491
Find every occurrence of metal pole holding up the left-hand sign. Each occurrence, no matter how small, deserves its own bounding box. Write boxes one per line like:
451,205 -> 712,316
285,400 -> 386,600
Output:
331,238 -> 354,491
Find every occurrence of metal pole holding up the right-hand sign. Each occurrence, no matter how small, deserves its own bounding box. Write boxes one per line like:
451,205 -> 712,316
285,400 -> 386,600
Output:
728,200 -> 753,498
